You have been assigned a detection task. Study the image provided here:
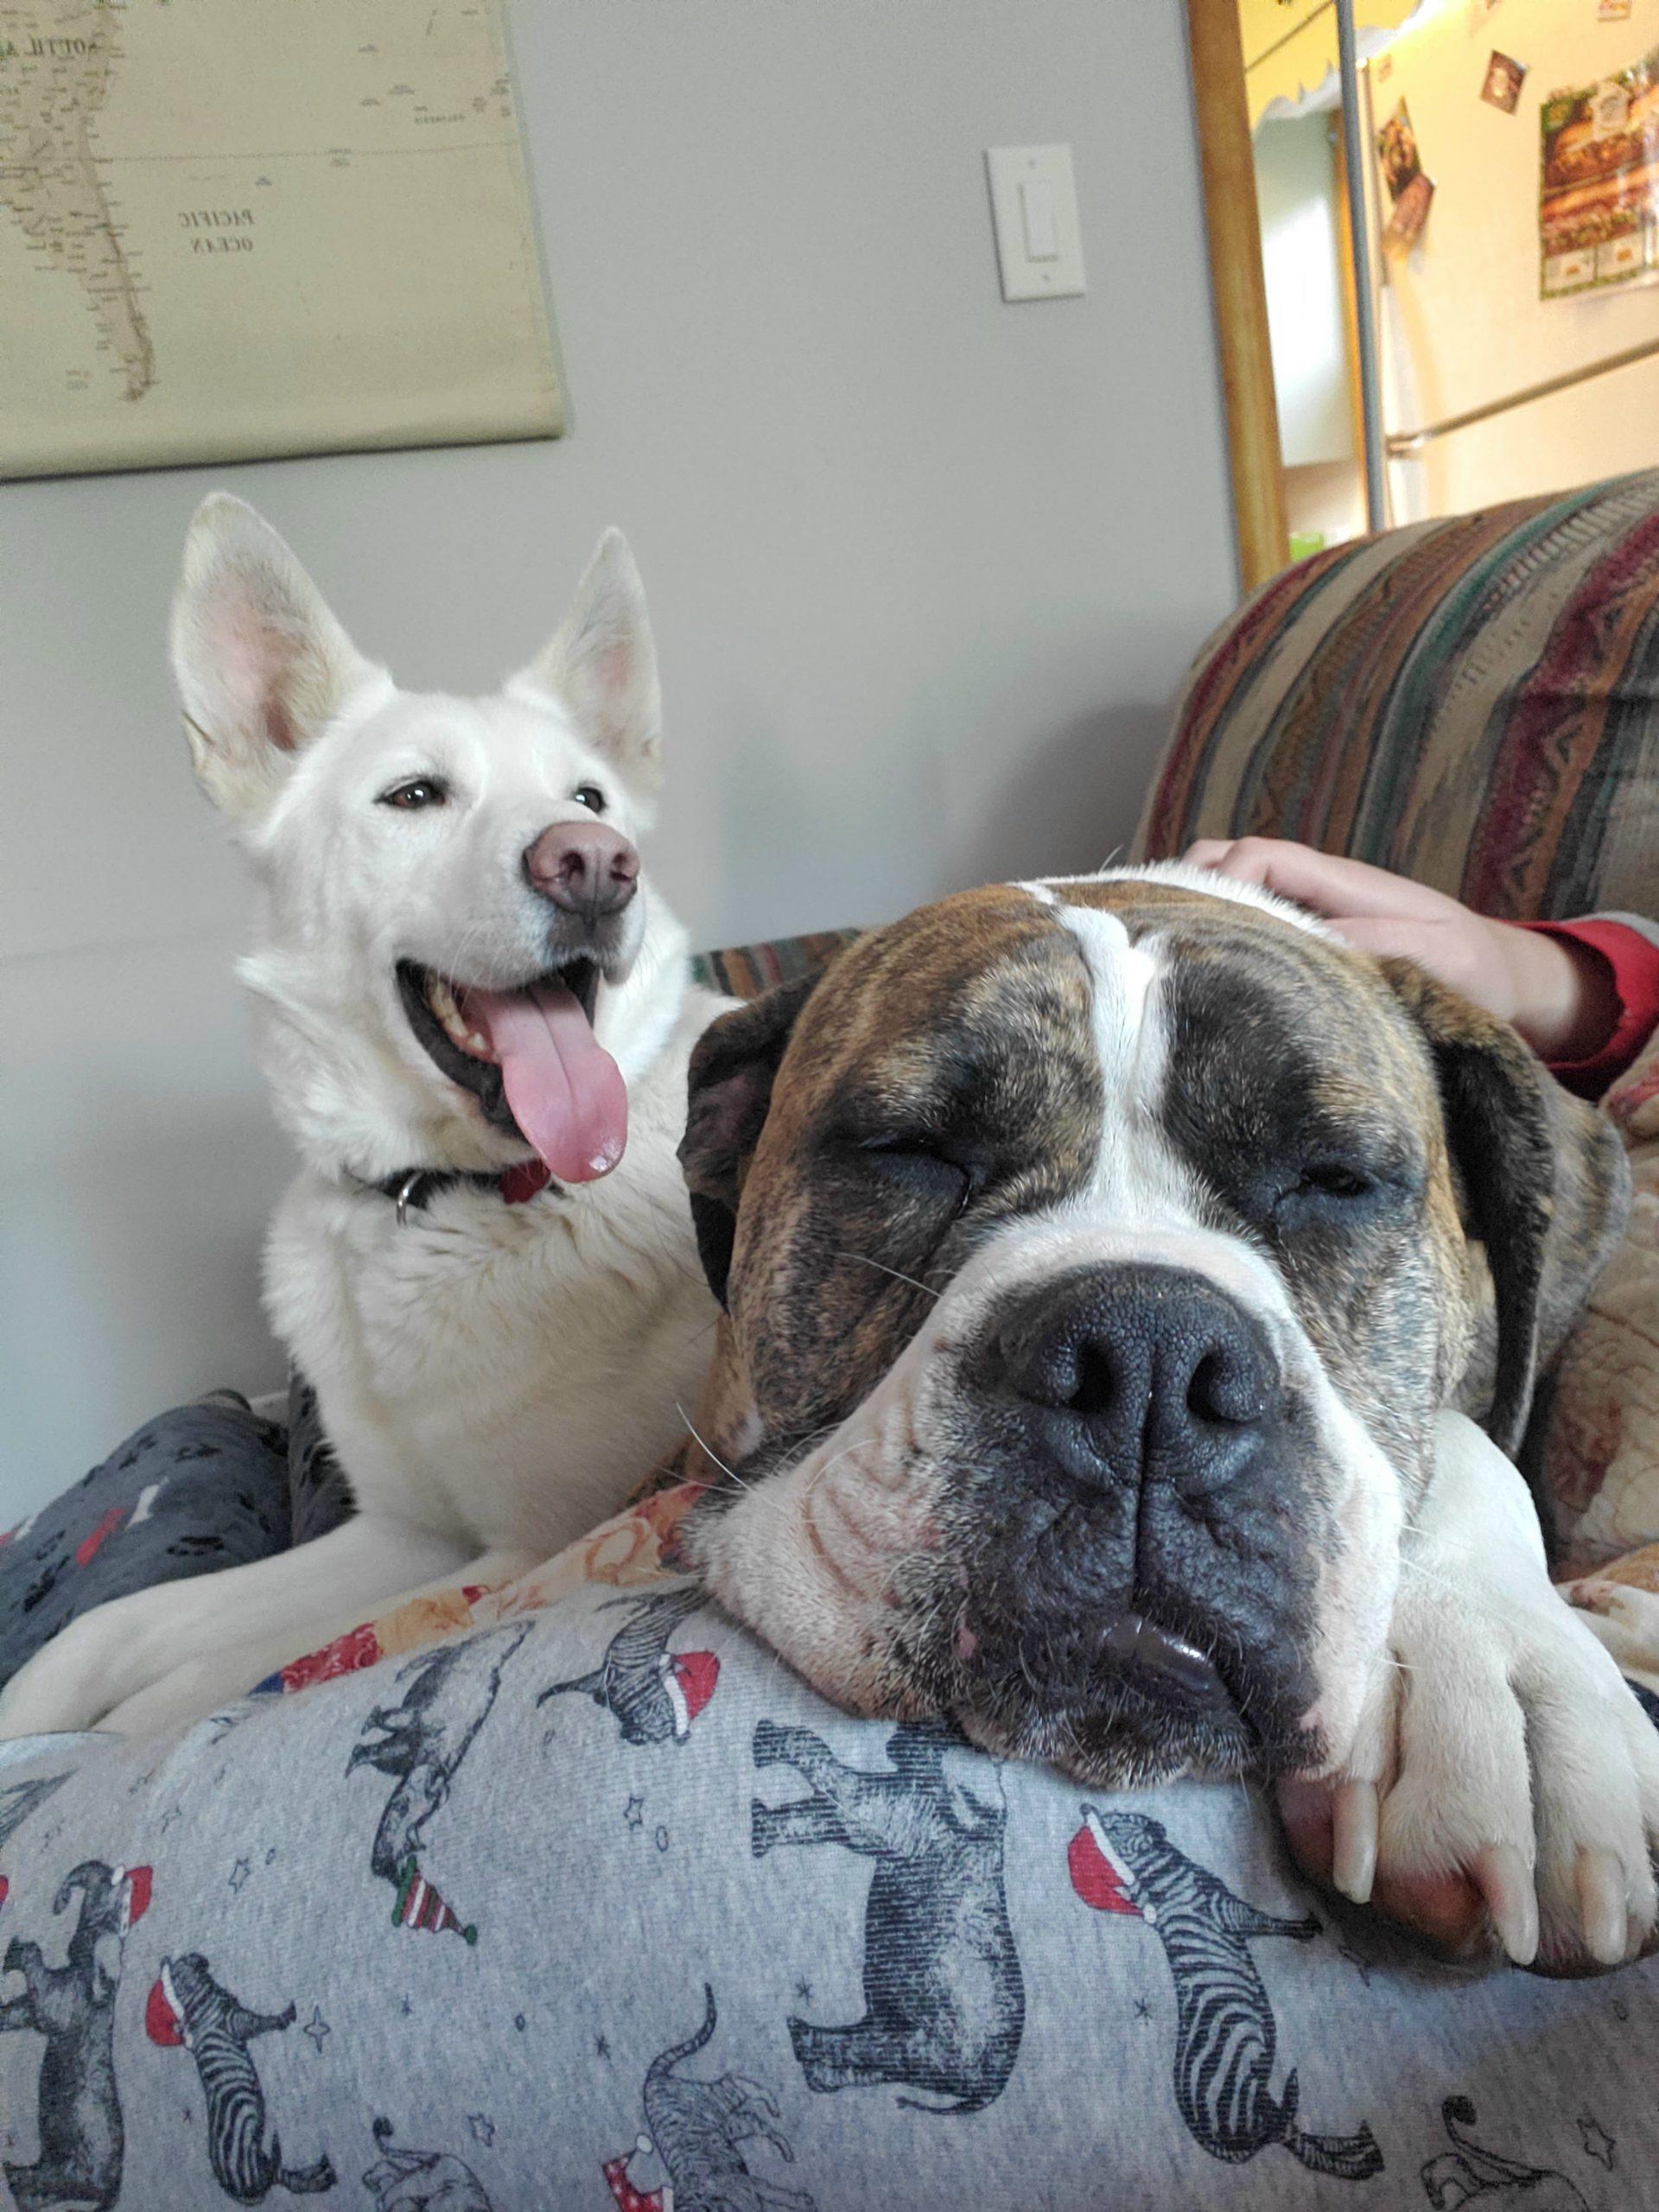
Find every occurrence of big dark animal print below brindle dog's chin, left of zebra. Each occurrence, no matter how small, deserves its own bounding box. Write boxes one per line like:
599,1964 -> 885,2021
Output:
750,1721 -> 1027,2113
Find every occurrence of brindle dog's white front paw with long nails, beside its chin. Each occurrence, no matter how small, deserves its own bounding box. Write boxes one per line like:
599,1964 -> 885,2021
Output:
1287,1440 -> 1659,1974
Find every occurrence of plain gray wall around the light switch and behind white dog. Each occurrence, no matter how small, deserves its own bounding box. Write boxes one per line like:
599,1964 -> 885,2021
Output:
0,0 -> 1234,1526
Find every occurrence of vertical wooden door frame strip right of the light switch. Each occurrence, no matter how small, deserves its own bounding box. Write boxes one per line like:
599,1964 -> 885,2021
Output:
1185,0 -> 1289,591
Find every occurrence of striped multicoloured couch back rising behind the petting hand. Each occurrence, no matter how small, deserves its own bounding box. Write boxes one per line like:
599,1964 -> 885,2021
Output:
1137,469 -> 1659,918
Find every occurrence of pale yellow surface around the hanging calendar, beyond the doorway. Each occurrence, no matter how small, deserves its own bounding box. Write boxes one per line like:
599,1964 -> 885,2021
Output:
1380,0 -> 1659,520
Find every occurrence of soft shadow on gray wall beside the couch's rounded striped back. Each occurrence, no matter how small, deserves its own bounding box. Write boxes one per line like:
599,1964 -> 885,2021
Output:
951,702 -> 1170,887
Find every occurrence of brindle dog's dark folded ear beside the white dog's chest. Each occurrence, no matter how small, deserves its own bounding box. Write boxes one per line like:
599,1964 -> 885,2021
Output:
679,969 -> 823,1305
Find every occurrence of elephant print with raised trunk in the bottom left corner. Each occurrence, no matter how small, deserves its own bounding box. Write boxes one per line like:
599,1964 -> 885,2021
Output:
0,1858 -> 150,2212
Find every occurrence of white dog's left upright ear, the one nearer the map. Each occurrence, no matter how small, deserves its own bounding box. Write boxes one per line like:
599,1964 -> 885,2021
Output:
170,491 -> 385,823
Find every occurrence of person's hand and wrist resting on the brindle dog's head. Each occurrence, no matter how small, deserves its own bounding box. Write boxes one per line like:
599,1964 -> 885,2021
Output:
1184,836 -> 1619,1064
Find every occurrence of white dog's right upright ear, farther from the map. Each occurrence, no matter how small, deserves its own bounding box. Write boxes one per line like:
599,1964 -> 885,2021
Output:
506,531 -> 661,798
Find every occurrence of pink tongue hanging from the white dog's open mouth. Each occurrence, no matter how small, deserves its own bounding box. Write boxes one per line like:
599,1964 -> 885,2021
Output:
460,982 -> 628,1184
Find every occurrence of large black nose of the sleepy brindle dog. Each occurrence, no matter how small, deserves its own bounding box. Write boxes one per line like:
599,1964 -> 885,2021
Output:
982,1263 -> 1283,1489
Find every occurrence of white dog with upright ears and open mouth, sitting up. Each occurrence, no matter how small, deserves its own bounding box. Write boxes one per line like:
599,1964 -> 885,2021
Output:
0,493 -> 721,1737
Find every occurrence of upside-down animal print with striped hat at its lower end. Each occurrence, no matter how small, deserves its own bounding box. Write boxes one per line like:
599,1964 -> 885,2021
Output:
345,1621 -> 531,1942
